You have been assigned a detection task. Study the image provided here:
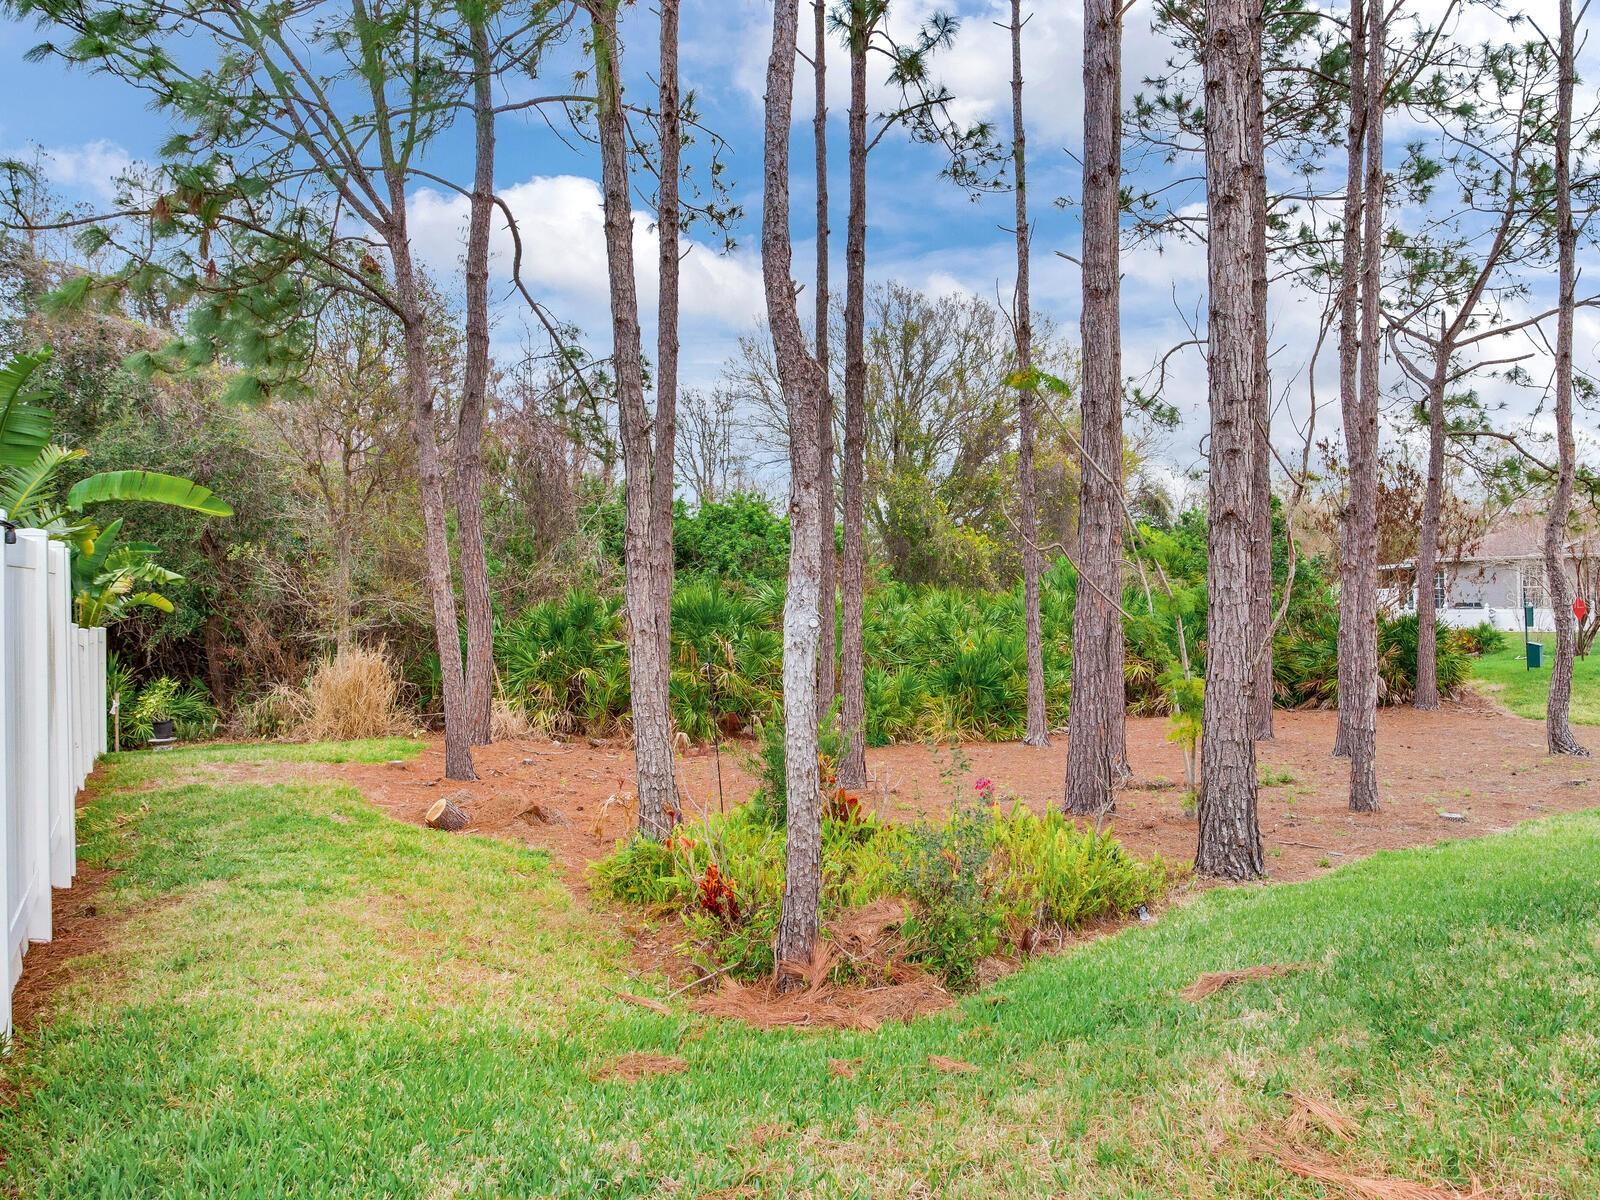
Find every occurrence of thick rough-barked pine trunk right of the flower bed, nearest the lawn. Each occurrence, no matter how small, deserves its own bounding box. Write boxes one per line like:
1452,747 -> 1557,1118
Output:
1195,0 -> 1264,880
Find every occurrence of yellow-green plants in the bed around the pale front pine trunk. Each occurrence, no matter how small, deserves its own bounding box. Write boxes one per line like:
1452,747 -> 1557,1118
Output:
590,781 -> 1170,990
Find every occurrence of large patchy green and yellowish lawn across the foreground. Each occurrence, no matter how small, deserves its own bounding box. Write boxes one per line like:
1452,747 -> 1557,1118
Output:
0,749 -> 1600,1200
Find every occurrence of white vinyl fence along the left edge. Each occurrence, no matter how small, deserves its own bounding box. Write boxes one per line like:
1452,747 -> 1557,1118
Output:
0,530 -> 106,1042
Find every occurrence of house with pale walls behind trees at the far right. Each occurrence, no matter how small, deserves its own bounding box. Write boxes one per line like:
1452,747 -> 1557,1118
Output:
1378,514 -> 1600,634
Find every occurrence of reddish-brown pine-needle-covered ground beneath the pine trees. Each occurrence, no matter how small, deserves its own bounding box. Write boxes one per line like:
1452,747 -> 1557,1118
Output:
328,702 -> 1600,888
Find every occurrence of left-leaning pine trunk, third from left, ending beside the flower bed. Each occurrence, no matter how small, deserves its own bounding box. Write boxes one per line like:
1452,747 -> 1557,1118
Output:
587,0 -> 677,838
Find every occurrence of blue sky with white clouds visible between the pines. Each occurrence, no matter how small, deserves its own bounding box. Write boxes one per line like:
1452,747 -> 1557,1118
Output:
0,0 -> 1600,492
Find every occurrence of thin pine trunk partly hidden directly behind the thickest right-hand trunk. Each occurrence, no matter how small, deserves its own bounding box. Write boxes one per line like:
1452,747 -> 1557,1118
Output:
1245,2 -> 1274,741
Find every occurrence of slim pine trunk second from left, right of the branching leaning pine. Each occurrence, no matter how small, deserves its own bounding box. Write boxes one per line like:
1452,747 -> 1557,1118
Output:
454,19 -> 494,746
